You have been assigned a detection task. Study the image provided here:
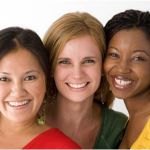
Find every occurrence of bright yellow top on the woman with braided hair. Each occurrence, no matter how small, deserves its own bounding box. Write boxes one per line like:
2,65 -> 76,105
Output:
131,119 -> 150,149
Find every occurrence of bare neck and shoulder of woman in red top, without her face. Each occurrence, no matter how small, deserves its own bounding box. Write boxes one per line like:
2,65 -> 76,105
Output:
0,121 -> 49,149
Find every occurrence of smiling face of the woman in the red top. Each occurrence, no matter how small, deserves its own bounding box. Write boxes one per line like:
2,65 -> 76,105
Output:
0,49 -> 46,123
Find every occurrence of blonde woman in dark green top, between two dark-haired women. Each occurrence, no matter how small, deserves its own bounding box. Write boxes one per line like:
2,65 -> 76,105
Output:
44,12 -> 127,149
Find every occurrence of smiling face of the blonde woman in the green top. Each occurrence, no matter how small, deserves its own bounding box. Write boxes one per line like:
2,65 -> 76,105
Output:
54,35 -> 102,102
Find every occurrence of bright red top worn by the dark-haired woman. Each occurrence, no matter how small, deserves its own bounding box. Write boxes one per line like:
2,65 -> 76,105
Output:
23,128 -> 80,149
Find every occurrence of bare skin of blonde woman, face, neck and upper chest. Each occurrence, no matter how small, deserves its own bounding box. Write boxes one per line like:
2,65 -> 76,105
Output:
47,35 -> 102,148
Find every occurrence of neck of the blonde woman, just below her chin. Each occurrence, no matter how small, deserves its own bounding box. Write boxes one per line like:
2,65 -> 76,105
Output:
57,99 -> 93,125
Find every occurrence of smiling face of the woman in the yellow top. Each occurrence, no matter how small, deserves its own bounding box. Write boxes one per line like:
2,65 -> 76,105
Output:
104,29 -> 150,99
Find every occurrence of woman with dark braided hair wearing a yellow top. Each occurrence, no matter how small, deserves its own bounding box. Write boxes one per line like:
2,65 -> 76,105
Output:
104,10 -> 150,149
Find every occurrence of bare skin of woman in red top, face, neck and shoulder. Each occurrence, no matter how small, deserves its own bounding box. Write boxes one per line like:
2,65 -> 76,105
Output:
0,48 -> 48,148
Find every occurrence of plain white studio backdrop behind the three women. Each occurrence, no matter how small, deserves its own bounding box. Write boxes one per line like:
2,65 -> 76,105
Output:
0,0 -> 150,115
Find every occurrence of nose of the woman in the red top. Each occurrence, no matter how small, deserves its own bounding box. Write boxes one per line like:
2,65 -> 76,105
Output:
10,82 -> 26,98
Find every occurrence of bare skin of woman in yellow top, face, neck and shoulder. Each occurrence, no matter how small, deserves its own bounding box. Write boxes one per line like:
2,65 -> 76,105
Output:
104,29 -> 150,149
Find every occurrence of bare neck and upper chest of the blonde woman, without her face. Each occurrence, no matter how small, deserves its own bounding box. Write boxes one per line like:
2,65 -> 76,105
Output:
47,97 -> 101,148
